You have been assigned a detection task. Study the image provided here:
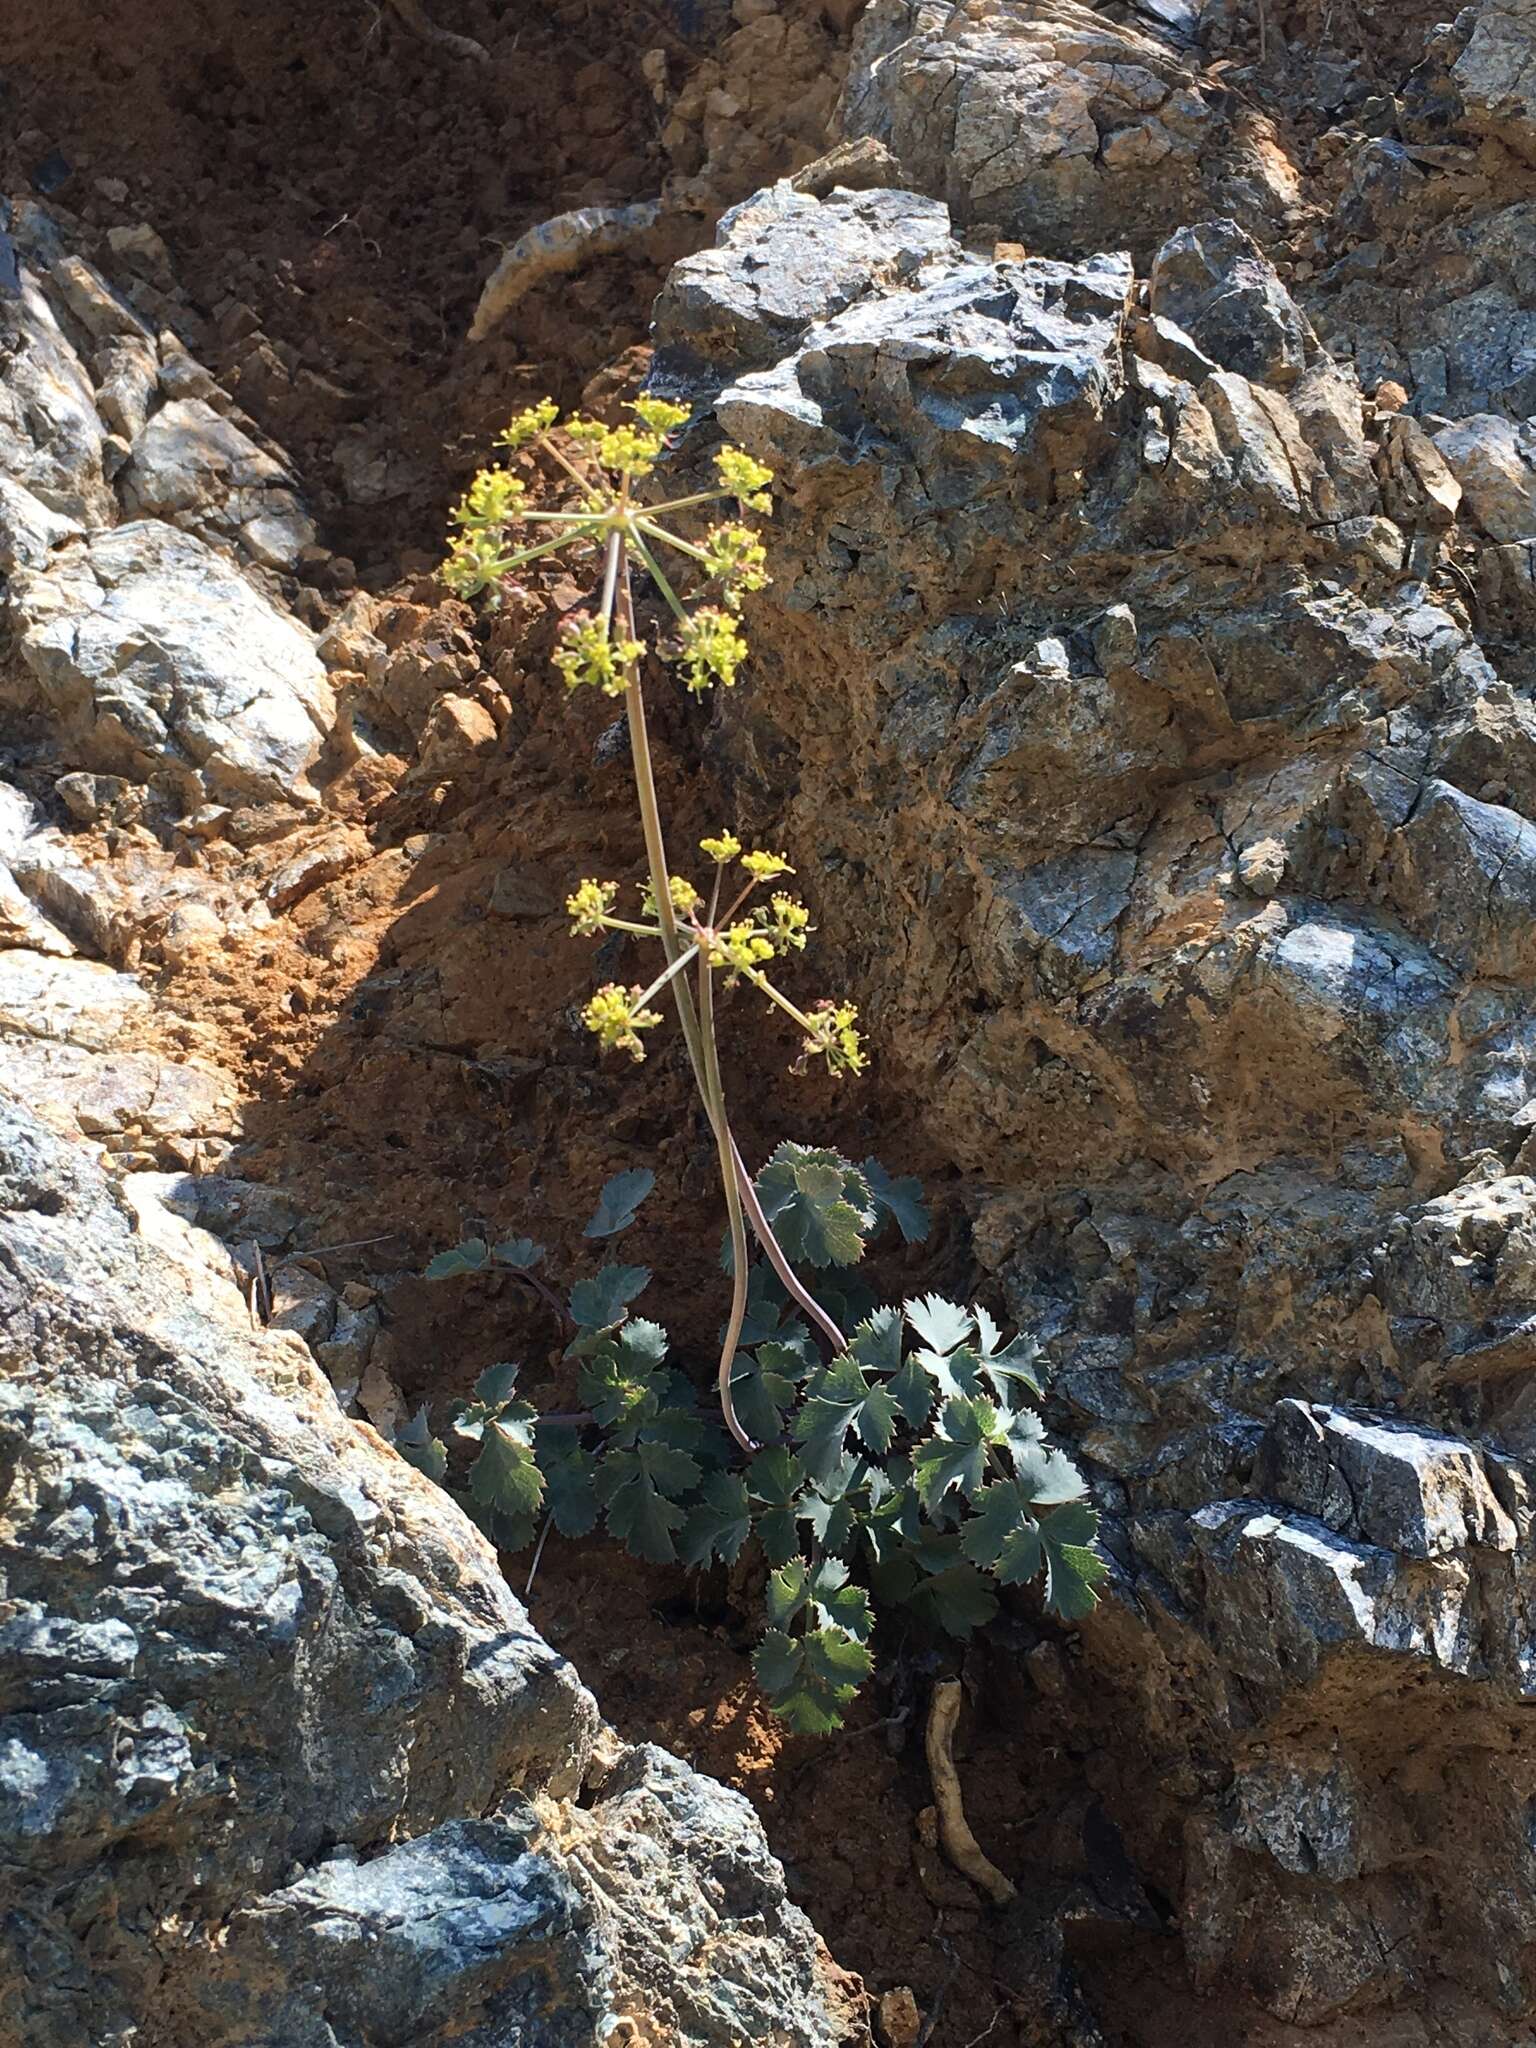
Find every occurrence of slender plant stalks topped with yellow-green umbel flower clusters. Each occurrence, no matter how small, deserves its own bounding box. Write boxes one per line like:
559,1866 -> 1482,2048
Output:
442,397 -> 866,1452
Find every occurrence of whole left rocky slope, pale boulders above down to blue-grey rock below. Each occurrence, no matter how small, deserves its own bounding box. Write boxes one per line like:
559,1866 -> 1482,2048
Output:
0,176 -> 864,2048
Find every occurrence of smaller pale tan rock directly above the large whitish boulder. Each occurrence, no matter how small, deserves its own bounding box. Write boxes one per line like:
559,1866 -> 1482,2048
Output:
119,397 -> 315,569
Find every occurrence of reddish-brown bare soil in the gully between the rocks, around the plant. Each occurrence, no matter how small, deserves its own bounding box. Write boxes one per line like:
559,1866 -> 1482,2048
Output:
0,0 -> 1204,2048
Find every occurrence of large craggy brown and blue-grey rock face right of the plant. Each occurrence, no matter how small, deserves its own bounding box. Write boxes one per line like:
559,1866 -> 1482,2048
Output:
657,59 -> 1536,2015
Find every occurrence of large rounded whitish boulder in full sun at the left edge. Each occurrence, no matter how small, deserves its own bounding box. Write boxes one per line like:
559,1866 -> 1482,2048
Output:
12,520 -> 334,809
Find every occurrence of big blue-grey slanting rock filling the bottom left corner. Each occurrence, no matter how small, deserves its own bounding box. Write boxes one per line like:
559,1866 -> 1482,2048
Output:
0,1105 -> 858,2048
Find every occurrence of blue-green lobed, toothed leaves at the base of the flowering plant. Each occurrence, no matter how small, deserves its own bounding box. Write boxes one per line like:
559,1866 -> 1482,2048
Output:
397,1145 -> 1104,1733
